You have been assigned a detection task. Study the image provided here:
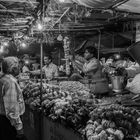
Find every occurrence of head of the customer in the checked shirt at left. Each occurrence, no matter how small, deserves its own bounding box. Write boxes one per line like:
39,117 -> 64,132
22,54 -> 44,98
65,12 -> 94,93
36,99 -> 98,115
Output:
2,56 -> 18,73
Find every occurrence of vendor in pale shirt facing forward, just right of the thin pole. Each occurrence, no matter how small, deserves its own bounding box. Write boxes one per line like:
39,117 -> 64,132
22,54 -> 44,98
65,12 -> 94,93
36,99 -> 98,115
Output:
31,55 -> 58,80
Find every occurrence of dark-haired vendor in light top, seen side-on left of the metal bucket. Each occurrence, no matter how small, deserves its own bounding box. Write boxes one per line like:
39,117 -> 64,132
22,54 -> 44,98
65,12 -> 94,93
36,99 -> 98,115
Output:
83,46 -> 108,94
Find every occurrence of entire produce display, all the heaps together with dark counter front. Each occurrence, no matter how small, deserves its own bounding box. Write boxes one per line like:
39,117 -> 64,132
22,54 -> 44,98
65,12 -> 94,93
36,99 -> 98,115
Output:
23,81 -> 140,140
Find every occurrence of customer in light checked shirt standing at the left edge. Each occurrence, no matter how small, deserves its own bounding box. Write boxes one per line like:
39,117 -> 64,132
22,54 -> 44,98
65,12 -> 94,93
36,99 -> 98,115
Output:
0,57 -> 25,140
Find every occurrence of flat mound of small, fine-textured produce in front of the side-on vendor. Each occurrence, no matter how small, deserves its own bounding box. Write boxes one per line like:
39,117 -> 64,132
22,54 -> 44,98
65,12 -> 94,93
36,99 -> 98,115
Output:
59,81 -> 90,97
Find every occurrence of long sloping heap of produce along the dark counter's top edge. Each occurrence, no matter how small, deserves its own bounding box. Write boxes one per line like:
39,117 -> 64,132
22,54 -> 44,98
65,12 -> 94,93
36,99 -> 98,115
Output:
23,82 -> 96,132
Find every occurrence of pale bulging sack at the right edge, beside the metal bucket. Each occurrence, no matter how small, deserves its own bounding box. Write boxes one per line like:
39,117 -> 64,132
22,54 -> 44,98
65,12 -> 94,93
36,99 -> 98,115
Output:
126,74 -> 140,94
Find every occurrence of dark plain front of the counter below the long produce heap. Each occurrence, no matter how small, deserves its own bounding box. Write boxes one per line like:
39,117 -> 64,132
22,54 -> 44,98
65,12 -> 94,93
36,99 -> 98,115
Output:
23,105 -> 84,140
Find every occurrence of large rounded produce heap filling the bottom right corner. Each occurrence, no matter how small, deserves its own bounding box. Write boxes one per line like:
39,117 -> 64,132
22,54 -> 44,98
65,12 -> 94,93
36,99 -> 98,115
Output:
85,105 -> 140,140
